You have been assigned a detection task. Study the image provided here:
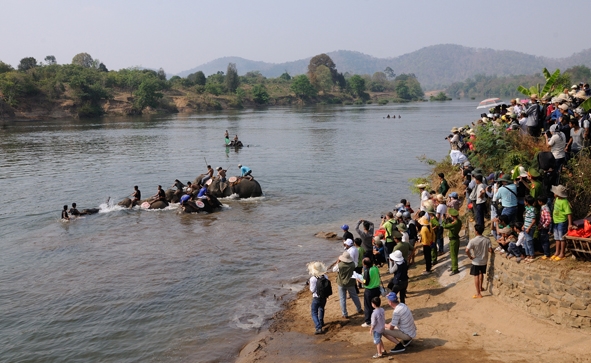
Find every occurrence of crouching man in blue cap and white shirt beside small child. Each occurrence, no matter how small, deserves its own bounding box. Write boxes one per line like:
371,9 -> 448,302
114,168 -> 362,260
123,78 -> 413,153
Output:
382,292 -> 417,353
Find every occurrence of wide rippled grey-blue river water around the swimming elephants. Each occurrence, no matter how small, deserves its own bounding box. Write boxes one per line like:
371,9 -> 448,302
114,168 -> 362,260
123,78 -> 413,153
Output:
0,101 -> 478,362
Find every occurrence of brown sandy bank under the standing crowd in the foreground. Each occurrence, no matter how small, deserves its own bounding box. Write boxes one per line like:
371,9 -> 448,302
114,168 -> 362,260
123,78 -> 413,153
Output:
237,232 -> 591,363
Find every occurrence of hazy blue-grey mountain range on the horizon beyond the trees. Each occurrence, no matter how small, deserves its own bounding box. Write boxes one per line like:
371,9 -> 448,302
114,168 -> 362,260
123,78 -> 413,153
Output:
178,44 -> 591,90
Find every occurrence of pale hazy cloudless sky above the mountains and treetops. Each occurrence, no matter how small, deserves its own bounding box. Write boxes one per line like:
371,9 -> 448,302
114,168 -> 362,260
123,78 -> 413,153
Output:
0,0 -> 591,75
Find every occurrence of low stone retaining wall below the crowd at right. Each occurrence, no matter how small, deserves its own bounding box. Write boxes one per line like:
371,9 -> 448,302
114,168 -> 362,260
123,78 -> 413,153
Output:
494,254 -> 591,331
